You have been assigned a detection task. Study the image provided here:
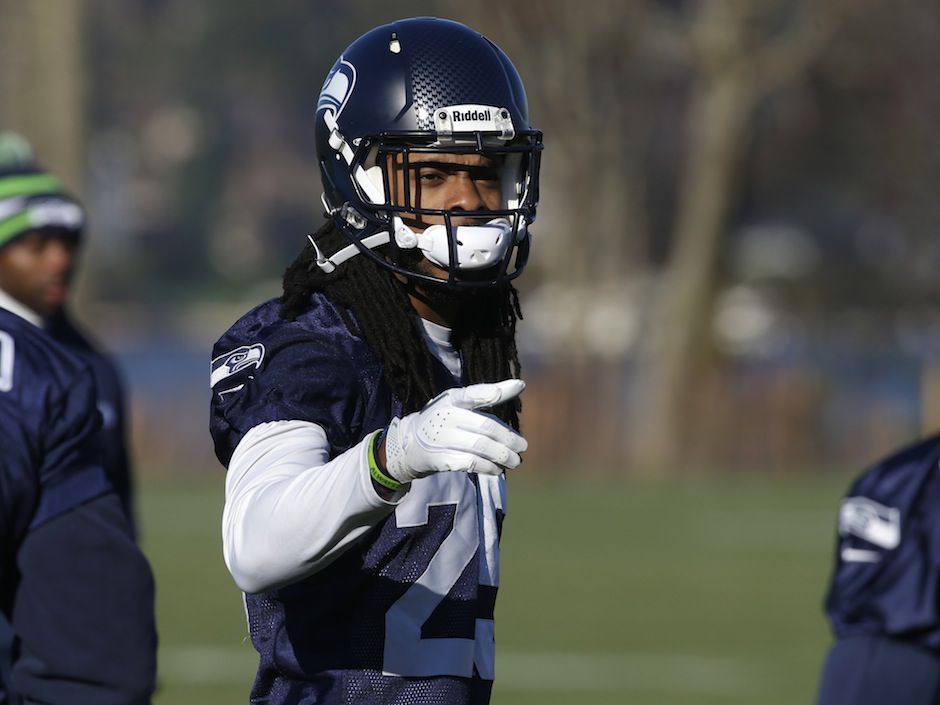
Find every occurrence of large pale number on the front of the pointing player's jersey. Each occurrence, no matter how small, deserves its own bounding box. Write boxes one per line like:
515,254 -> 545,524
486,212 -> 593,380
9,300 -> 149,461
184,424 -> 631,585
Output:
383,473 -> 495,680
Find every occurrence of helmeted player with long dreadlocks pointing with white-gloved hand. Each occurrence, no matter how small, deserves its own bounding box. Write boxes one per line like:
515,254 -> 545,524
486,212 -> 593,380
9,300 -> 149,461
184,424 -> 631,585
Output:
211,18 -> 542,705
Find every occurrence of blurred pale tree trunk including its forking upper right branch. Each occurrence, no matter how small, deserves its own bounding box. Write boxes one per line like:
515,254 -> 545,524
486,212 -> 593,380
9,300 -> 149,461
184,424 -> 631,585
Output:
634,0 -> 845,473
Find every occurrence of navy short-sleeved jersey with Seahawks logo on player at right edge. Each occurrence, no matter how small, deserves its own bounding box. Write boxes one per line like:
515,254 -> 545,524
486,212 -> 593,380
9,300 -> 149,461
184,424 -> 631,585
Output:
826,436 -> 940,649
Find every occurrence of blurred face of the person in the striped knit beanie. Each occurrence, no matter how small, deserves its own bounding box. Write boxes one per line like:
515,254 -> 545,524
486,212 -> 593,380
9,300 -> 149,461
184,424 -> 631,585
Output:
0,231 -> 78,316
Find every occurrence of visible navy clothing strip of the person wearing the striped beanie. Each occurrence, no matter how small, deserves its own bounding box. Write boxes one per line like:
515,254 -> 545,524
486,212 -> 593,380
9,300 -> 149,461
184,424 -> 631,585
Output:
45,312 -> 133,521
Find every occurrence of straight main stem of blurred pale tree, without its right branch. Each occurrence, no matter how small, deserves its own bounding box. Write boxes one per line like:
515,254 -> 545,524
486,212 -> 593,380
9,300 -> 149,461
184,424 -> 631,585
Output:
634,0 -> 753,473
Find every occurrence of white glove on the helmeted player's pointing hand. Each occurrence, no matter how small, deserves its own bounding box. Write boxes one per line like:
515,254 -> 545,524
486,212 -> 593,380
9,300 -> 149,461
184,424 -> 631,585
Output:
385,379 -> 529,483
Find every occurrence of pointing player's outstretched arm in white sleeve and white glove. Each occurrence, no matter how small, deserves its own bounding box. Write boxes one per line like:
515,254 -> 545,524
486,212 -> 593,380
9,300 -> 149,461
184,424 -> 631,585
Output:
222,380 -> 526,593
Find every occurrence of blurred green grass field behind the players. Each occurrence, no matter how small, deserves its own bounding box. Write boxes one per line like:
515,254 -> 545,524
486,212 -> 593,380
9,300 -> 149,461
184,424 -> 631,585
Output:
139,470 -> 848,705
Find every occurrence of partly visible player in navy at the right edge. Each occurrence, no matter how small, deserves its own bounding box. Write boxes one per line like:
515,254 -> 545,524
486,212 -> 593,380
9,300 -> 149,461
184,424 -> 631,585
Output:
818,436 -> 940,705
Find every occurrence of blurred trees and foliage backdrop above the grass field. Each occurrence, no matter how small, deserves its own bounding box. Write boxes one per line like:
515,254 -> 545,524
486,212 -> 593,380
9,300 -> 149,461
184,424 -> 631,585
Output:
0,0 -> 940,474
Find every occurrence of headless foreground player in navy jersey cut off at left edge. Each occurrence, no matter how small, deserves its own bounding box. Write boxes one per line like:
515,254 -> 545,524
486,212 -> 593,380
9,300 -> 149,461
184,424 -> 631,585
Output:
0,308 -> 156,705
